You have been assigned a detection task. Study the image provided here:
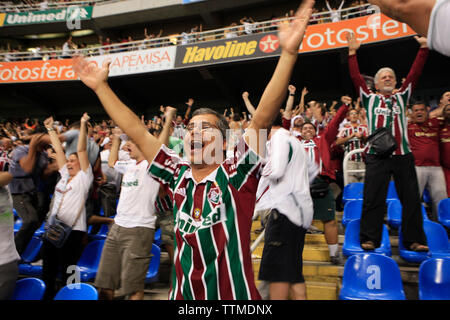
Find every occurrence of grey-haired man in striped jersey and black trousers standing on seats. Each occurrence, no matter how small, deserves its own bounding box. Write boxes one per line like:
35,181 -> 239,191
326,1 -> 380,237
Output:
347,33 -> 428,251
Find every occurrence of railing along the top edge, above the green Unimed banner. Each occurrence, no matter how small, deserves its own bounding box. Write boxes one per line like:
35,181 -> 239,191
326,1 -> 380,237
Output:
0,0 -> 121,12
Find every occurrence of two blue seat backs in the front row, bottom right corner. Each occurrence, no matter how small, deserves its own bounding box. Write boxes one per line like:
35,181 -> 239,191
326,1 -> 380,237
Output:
339,253 -> 450,300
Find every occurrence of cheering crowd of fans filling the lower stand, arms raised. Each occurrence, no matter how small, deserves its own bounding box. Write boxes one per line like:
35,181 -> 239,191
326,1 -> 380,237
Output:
0,0 -> 450,299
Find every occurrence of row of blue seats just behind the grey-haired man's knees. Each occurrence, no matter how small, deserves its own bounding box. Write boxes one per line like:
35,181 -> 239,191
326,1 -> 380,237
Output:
342,198 -> 450,229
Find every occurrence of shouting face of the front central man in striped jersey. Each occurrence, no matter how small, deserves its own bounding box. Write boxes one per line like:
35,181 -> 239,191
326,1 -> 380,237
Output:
184,114 -> 226,165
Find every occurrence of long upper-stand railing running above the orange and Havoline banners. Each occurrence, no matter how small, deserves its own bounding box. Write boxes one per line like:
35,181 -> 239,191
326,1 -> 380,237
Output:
0,4 -> 375,62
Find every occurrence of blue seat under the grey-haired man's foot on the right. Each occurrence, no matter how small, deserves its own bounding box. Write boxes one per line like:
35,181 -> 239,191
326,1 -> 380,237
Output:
398,220 -> 450,263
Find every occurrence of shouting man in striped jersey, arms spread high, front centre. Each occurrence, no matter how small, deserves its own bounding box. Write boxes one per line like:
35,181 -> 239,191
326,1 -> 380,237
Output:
73,0 -> 314,300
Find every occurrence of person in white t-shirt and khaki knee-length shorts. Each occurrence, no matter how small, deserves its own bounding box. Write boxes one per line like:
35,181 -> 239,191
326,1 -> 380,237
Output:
95,134 -> 159,300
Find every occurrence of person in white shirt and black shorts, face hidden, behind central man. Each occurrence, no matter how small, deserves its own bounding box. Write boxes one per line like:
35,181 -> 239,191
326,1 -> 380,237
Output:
257,114 -> 318,300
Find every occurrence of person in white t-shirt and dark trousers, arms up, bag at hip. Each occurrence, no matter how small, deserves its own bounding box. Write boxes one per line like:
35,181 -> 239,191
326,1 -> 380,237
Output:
42,113 -> 94,300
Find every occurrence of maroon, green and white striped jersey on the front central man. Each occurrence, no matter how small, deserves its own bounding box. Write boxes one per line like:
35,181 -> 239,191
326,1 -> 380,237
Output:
149,138 -> 261,300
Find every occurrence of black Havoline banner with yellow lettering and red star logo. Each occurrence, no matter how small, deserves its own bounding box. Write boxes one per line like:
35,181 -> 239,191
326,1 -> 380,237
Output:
175,32 -> 281,68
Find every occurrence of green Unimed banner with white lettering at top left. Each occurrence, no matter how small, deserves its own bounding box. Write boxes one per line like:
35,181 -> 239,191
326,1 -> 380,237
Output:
0,6 -> 92,27
